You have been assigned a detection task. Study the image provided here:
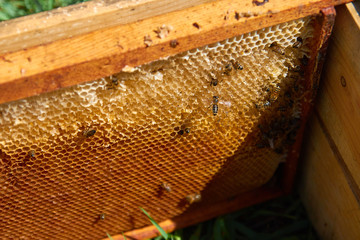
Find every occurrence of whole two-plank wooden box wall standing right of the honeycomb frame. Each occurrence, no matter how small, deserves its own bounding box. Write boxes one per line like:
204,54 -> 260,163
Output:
299,4 -> 360,240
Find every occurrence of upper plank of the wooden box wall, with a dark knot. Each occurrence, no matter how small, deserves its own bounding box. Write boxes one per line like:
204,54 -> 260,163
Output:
316,4 -> 360,194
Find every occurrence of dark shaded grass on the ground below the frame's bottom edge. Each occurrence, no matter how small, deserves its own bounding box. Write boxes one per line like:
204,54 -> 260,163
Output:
141,195 -> 318,240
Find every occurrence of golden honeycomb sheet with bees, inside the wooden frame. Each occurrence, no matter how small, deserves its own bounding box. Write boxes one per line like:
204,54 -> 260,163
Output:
0,17 -> 314,239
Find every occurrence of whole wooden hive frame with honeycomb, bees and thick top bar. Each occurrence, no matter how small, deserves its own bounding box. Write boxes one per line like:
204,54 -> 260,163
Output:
0,0 -> 352,239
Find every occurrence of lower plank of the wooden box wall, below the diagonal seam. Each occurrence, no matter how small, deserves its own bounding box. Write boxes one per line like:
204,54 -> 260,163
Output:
300,114 -> 360,240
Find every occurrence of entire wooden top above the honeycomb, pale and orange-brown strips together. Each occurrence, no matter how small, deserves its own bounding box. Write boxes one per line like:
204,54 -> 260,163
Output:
0,0 -> 349,103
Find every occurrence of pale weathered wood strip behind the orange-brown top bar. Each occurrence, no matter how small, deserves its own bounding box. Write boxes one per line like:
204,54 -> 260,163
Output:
0,0 -> 214,54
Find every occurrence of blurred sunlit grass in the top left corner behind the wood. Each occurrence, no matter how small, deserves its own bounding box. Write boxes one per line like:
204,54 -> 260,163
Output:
0,0 -> 86,21
